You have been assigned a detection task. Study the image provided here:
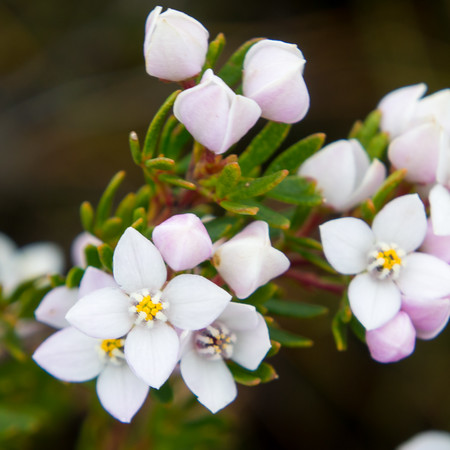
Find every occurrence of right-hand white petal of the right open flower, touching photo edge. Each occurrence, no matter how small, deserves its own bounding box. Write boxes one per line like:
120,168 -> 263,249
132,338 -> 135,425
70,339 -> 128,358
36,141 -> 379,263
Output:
397,253 -> 450,299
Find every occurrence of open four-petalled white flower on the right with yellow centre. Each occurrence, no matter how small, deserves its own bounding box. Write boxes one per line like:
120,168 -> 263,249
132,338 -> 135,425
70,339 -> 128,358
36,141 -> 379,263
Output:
320,194 -> 450,330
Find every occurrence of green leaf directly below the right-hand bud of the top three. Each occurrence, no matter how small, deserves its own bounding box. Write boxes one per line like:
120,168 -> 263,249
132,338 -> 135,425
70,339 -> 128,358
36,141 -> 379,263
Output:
239,122 -> 291,175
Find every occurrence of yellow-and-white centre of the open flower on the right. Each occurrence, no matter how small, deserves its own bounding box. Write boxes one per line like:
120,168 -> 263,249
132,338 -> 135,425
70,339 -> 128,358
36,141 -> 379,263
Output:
367,243 -> 405,280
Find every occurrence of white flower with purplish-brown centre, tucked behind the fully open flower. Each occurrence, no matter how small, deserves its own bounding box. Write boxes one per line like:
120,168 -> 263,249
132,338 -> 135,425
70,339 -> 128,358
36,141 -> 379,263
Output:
180,303 -> 271,413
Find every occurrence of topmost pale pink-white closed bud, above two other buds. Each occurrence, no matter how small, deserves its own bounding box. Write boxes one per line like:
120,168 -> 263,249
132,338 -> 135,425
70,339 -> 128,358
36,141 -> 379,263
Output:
144,6 -> 209,81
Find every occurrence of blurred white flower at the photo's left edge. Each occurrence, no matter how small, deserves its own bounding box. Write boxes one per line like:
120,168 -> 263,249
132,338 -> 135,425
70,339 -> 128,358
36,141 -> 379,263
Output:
0,233 -> 64,293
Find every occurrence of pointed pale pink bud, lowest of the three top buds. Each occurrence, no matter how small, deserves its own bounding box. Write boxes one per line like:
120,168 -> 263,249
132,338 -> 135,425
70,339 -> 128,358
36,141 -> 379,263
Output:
173,69 -> 261,154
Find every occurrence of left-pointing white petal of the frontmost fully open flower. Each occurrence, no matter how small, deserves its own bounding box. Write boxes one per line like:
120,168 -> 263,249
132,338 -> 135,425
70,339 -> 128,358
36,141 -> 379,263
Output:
66,288 -> 135,339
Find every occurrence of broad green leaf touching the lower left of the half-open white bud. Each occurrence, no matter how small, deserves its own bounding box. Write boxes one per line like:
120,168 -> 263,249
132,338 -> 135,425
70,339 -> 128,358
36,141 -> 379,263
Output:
267,175 -> 322,206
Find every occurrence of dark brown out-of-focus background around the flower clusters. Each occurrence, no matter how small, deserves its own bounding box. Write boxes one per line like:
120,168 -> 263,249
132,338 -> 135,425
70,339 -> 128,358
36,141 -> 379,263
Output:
0,0 -> 450,449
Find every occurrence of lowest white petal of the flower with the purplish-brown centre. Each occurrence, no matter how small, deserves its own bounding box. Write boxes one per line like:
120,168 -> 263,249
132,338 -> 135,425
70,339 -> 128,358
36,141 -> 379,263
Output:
180,350 -> 237,413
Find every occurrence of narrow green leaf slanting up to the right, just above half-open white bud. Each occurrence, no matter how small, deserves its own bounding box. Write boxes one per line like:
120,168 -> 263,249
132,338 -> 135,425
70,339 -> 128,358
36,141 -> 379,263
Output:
266,133 -> 325,175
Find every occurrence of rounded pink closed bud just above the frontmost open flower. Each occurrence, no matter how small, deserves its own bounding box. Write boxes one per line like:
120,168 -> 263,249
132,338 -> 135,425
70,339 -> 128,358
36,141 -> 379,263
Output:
152,214 -> 212,271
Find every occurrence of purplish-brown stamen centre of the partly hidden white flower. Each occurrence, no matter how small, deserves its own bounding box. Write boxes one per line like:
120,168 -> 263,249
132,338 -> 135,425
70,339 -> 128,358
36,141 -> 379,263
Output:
194,323 -> 236,359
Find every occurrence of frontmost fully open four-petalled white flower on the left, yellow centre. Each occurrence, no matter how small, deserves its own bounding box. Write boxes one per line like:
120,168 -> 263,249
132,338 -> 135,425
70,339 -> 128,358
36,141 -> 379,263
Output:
66,228 -> 231,388
